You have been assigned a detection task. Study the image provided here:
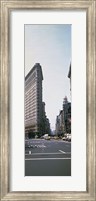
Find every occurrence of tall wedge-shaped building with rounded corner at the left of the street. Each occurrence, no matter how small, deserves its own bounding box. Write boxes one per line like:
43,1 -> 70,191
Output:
25,63 -> 43,134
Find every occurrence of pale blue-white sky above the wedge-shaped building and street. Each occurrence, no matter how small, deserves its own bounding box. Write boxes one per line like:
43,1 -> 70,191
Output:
25,24 -> 71,130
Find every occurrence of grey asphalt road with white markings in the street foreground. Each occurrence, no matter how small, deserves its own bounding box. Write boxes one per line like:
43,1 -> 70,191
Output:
25,139 -> 71,176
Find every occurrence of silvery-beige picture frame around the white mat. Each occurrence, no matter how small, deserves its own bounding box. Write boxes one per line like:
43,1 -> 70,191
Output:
0,0 -> 96,201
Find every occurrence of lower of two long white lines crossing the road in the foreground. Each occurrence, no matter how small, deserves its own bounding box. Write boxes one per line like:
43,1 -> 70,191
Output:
25,158 -> 71,161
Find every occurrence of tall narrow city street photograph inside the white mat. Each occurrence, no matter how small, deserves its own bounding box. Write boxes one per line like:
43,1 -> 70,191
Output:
24,24 -> 71,176
